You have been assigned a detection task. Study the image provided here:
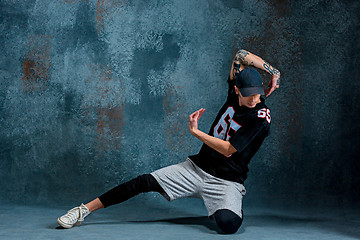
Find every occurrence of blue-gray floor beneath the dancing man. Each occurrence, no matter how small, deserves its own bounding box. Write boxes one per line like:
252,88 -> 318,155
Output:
0,199 -> 360,240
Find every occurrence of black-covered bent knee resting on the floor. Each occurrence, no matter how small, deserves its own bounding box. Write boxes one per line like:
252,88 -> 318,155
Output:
214,209 -> 242,234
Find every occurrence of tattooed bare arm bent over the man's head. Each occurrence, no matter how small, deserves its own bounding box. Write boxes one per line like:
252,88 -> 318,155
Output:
230,49 -> 280,97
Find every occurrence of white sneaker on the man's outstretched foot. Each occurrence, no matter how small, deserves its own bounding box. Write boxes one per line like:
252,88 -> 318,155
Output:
57,204 -> 90,228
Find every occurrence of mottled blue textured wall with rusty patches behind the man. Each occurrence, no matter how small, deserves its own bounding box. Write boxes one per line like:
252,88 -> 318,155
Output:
0,0 -> 360,206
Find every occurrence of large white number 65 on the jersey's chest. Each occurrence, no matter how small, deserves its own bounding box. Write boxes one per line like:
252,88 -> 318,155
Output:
214,107 -> 241,141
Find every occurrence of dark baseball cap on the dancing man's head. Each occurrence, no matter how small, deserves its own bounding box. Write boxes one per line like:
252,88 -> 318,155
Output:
235,68 -> 265,97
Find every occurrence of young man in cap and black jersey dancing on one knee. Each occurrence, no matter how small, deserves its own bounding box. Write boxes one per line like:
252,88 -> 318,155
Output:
57,50 -> 280,234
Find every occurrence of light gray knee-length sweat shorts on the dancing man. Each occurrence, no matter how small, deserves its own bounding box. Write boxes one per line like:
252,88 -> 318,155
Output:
151,158 -> 246,218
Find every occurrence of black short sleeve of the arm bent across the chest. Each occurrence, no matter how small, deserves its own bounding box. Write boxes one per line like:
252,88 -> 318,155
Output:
229,118 -> 270,152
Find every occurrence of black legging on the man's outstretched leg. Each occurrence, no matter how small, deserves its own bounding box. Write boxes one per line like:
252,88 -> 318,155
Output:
99,174 -> 165,207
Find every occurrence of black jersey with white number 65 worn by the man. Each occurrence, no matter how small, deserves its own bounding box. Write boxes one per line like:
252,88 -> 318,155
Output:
189,80 -> 271,183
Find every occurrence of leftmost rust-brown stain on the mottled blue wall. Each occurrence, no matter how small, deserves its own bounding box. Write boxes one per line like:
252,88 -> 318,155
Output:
22,35 -> 51,91
